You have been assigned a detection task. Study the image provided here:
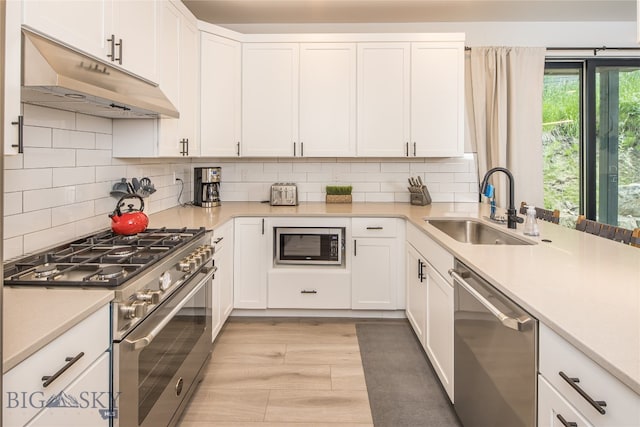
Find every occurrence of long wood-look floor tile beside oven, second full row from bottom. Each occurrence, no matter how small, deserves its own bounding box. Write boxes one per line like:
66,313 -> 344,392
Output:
203,363 -> 331,390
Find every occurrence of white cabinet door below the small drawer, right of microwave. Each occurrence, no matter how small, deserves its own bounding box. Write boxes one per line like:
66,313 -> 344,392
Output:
351,238 -> 398,310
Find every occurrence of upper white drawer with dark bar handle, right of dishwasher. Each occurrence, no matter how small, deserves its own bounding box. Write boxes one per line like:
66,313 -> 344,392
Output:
540,324 -> 640,427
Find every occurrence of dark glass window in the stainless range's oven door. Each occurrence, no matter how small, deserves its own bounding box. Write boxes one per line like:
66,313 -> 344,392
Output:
138,286 -> 207,425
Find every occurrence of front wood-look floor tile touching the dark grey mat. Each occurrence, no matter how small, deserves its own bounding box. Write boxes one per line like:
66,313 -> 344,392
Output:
265,390 -> 373,423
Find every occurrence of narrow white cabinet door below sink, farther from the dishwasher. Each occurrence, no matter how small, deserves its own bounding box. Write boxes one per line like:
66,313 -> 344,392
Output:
407,245 -> 427,346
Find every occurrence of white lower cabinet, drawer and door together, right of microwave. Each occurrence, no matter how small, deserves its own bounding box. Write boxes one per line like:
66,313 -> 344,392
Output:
351,218 -> 404,310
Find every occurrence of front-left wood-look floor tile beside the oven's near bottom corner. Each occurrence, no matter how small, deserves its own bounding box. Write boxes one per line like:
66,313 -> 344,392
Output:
183,390 -> 269,425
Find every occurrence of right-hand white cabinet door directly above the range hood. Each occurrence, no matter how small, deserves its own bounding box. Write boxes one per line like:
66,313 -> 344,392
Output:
112,0 -> 158,82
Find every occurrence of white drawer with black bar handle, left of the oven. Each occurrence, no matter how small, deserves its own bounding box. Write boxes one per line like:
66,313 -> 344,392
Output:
3,305 -> 111,426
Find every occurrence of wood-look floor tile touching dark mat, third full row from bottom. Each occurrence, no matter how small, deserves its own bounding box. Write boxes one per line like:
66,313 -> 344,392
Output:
284,343 -> 361,365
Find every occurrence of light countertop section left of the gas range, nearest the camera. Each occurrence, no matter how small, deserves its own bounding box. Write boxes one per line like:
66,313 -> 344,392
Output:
2,286 -> 113,374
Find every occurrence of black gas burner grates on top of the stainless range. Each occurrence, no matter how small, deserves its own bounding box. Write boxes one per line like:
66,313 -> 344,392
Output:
4,227 -> 206,287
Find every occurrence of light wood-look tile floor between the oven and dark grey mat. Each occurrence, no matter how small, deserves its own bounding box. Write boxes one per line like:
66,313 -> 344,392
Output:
179,318 -> 373,427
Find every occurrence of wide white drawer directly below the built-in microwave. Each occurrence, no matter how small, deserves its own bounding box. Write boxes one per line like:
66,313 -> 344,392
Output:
267,270 -> 351,309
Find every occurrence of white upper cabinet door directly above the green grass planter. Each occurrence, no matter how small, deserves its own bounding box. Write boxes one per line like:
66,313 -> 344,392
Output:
297,43 -> 356,157
